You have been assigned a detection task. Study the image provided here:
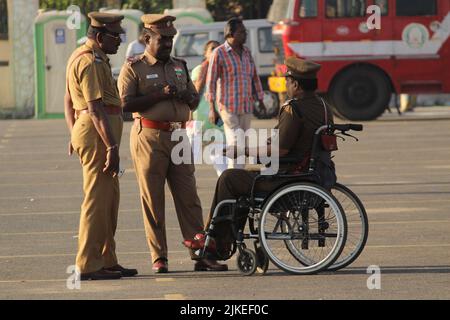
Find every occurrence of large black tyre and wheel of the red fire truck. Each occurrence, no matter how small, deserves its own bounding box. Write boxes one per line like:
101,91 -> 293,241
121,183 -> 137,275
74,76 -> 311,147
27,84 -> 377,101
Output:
329,66 -> 392,121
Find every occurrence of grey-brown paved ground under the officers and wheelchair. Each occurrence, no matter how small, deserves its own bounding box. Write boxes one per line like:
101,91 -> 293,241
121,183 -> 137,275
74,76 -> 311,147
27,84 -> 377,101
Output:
0,109 -> 450,300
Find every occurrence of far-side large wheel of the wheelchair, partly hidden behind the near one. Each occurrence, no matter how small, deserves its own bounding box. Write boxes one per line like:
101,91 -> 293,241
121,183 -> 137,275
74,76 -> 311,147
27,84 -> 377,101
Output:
328,183 -> 369,271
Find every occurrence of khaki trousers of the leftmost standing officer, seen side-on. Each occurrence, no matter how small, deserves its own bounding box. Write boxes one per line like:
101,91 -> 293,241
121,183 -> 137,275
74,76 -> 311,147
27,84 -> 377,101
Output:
72,114 -> 123,273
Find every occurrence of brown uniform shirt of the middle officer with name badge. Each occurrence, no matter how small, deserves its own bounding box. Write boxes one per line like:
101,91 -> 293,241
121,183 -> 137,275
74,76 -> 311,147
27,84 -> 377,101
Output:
118,51 -> 197,122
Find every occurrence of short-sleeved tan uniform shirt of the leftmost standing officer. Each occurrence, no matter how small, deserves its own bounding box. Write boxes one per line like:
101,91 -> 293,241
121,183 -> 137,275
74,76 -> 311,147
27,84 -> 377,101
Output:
66,40 -> 121,110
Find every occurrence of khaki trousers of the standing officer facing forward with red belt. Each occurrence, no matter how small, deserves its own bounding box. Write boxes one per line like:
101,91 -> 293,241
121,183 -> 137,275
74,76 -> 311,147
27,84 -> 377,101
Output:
130,124 -> 203,262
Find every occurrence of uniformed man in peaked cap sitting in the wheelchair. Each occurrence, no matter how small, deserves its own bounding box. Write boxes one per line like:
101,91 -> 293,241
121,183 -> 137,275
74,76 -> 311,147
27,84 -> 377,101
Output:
190,57 -> 333,258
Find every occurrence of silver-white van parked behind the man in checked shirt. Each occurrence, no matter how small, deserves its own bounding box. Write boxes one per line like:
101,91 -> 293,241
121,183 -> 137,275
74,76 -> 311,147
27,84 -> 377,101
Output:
172,19 -> 279,118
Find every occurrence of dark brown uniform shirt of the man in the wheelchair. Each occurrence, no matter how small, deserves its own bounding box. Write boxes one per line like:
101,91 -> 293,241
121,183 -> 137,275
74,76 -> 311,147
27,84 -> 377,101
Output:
276,93 -> 333,159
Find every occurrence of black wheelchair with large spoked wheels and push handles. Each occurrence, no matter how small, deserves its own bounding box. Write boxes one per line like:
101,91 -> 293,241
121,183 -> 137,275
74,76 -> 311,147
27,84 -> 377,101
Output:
196,124 -> 368,275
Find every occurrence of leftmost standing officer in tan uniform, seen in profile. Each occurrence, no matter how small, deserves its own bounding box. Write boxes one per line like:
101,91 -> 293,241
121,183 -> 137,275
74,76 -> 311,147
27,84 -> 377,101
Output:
64,12 -> 137,280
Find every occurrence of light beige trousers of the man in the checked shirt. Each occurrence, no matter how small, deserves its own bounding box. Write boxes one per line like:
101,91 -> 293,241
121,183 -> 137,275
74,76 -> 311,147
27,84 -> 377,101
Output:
219,109 -> 252,169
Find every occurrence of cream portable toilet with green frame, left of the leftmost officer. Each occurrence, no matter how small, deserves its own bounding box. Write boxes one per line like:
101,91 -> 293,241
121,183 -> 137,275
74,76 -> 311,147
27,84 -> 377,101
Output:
34,11 -> 87,119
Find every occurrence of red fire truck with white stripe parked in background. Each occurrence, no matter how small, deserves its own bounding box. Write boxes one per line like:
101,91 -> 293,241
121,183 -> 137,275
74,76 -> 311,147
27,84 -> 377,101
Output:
268,0 -> 450,120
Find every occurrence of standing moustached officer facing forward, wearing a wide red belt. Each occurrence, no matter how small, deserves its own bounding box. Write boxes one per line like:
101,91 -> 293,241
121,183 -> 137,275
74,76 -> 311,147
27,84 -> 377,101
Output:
118,14 -> 229,273
